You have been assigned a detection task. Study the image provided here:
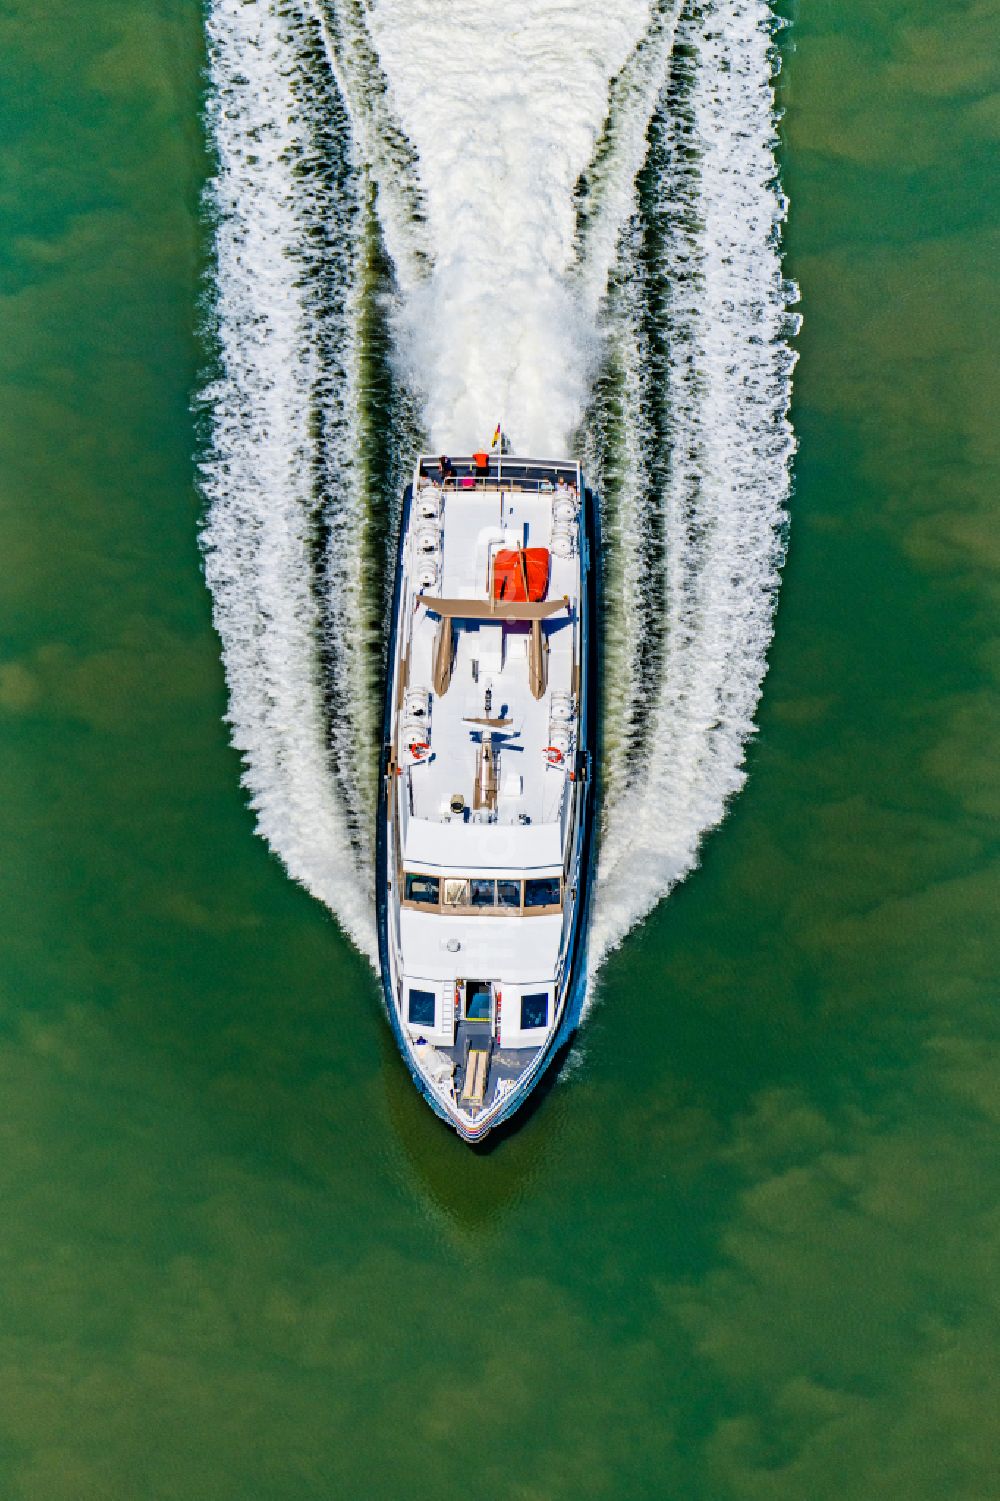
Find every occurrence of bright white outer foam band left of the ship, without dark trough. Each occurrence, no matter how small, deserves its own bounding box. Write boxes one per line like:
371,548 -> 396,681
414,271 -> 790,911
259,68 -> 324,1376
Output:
203,0 -> 375,956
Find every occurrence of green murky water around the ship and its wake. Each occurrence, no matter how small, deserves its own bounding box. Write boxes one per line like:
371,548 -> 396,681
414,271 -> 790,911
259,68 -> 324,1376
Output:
0,0 -> 1000,1501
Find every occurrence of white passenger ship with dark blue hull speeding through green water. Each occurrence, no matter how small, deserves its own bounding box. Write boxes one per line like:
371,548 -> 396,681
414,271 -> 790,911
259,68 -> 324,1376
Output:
377,450 -> 598,1142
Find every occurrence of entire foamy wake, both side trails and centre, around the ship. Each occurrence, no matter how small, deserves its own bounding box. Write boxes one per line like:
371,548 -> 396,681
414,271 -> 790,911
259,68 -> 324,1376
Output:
203,0 -> 794,984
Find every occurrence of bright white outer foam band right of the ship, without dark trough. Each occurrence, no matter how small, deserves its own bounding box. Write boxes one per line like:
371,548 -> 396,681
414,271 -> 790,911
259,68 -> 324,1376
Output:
593,0 -> 794,961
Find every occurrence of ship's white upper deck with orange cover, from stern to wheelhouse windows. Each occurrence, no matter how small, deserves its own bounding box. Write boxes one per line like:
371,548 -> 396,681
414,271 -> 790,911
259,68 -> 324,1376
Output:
395,458 -> 581,871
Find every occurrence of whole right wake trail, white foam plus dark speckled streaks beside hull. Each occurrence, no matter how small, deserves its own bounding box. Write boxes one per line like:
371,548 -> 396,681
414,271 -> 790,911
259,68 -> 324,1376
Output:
593,0 -> 797,961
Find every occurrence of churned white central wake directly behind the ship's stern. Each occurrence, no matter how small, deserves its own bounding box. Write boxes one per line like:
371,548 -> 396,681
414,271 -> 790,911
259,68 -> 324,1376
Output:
371,0 -> 650,455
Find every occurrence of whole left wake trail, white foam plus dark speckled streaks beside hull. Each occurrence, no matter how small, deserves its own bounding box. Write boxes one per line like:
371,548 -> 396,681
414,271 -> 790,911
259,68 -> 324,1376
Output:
201,0 -> 411,956
